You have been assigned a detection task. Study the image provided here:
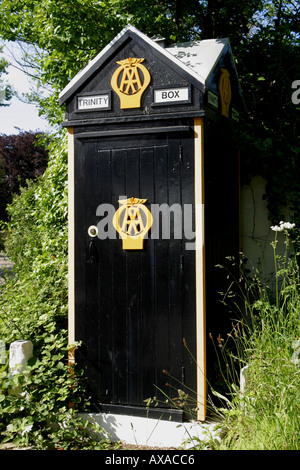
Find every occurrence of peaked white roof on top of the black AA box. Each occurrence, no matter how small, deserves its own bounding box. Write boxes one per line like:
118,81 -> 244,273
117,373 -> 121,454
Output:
59,24 -> 229,105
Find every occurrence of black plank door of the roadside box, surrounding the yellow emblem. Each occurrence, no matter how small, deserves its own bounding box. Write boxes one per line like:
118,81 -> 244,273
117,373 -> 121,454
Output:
75,127 -> 196,407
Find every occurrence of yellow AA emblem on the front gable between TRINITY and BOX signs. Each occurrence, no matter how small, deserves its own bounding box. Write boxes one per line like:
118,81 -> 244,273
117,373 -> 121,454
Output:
111,57 -> 151,109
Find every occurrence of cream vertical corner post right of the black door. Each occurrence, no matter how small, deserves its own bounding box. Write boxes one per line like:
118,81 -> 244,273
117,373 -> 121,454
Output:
194,118 -> 206,421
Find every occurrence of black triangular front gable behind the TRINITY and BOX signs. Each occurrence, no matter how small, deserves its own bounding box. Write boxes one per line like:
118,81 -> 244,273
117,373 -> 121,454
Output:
65,32 -> 204,126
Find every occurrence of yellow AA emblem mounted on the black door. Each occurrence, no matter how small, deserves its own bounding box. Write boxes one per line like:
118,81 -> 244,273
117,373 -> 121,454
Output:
112,197 -> 153,250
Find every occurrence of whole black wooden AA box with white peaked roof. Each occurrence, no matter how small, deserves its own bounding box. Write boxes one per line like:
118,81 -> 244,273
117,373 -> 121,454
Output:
60,25 -> 242,421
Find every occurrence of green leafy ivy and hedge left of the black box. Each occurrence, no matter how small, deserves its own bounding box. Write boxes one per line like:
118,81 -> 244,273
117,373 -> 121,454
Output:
0,134 -> 113,449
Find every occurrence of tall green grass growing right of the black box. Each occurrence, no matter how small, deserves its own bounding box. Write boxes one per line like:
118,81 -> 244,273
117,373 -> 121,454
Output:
206,223 -> 300,450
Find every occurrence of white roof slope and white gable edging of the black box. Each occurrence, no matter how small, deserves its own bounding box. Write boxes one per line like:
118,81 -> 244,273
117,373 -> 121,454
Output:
59,24 -> 228,102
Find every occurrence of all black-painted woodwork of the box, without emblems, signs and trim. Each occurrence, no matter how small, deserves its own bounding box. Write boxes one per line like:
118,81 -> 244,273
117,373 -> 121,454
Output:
61,26 -> 241,419
